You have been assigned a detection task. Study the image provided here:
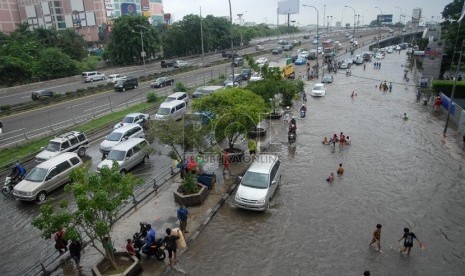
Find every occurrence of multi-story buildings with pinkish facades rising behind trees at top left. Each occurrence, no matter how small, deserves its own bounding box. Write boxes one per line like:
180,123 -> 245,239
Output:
0,0 -> 164,41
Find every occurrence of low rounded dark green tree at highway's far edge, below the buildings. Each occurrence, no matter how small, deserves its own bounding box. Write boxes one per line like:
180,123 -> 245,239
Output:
34,48 -> 78,80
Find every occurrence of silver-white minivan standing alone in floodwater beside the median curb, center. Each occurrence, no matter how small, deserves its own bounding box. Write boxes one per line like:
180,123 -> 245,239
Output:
234,154 -> 281,211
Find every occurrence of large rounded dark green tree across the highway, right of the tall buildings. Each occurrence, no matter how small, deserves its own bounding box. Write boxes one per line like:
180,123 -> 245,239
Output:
104,15 -> 160,65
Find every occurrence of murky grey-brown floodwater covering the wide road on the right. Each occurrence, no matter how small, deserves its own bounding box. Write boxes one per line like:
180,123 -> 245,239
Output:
172,51 -> 465,275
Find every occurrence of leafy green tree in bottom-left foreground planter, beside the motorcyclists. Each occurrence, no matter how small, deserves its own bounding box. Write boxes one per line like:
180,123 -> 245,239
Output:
32,162 -> 140,270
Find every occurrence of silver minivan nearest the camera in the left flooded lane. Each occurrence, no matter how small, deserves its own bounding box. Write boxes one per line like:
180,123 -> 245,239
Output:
13,152 -> 83,202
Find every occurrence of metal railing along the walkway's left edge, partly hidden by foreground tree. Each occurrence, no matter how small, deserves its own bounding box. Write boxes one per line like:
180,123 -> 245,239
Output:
19,167 -> 177,276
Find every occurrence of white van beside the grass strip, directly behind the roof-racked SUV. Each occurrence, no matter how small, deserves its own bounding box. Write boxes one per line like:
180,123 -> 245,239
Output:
100,124 -> 145,156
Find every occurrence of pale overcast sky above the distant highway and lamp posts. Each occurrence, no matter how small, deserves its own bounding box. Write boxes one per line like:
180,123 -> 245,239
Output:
163,0 -> 453,26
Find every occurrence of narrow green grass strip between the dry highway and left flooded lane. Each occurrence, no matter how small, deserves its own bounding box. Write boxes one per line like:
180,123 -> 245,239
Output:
0,99 -> 157,169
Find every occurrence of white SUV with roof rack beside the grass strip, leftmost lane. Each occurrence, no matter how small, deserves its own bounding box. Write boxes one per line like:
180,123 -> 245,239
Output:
35,131 -> 89,162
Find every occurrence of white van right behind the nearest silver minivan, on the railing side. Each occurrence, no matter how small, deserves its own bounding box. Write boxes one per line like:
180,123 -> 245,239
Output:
97,138 -> 149,174
